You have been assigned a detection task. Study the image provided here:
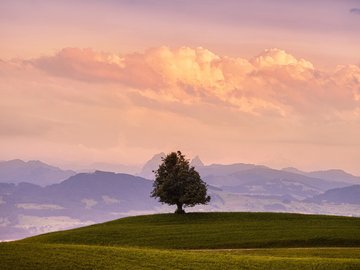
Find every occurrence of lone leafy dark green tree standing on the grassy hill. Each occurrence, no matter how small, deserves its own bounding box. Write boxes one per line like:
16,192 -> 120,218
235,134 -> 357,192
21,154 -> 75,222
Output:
151,151 -> 210,214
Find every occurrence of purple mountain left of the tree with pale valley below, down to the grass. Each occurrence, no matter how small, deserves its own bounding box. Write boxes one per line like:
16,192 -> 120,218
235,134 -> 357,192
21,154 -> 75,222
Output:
0,171 -> 161,240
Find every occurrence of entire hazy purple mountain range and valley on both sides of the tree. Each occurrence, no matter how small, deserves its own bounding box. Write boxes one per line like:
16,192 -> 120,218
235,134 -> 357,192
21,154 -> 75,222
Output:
0,153 -> 360,240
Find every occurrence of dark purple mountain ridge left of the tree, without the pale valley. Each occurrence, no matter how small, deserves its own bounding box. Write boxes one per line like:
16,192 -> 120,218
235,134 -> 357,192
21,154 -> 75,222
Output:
0,171 -> 157,218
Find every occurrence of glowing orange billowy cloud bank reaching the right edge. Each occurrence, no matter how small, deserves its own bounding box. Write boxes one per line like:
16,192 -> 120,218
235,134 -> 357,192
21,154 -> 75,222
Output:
31,46 -> 360,116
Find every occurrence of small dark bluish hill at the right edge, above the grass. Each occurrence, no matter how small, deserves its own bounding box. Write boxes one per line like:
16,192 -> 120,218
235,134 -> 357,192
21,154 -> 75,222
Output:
309,185 -> 360,205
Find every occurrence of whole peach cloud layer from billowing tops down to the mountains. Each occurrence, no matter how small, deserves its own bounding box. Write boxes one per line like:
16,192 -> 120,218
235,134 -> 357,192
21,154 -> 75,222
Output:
0,47 -> 360,173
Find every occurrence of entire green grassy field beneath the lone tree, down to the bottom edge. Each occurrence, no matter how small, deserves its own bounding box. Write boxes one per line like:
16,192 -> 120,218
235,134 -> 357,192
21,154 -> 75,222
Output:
0,213 -> 360,270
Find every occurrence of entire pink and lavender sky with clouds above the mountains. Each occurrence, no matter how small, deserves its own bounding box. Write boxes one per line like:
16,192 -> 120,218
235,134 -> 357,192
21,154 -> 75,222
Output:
0,0 -> 360,175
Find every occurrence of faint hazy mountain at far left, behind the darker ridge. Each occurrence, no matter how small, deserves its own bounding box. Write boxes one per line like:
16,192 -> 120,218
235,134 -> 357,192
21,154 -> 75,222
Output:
0,159 -> 76,186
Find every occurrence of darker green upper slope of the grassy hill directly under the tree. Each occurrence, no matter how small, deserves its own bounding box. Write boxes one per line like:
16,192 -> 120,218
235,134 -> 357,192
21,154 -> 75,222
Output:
21,213 -> 360,249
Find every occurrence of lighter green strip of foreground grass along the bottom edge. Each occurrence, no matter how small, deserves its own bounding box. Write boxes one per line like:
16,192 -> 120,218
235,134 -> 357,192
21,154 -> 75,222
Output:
0,243 -> 360,270
